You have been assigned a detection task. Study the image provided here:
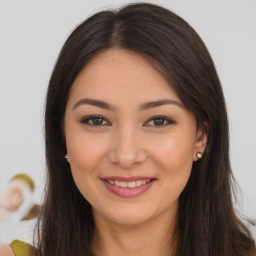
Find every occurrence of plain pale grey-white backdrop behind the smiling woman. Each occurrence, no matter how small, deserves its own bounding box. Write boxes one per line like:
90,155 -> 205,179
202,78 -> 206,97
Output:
0,0 -> 256,222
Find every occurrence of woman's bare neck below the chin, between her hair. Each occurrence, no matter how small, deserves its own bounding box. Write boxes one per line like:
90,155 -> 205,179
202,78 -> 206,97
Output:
92,208 -> 176,256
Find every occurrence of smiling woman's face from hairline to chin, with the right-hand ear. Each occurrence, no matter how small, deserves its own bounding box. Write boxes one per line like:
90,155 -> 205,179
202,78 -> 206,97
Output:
65,48 -> 206,225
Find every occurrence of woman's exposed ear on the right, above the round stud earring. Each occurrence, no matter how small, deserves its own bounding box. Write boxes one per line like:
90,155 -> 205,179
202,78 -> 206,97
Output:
193,124 -> 208,162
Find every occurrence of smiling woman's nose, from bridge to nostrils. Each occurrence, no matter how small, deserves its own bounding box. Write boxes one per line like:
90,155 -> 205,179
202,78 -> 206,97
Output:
108,125 -> 147,169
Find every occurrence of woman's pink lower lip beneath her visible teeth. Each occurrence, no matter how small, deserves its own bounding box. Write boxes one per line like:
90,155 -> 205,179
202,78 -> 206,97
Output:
102,180 -> 156,198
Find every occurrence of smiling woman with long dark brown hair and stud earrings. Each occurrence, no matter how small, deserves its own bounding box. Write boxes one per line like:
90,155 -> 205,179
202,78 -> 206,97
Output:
1,3 -> 255,256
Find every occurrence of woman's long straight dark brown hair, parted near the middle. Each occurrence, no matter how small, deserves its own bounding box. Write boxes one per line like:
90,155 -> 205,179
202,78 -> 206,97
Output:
34,3 -> 254,256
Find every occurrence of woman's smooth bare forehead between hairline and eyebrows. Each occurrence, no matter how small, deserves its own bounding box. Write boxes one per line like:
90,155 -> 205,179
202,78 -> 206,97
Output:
67,48 -> 181,105
